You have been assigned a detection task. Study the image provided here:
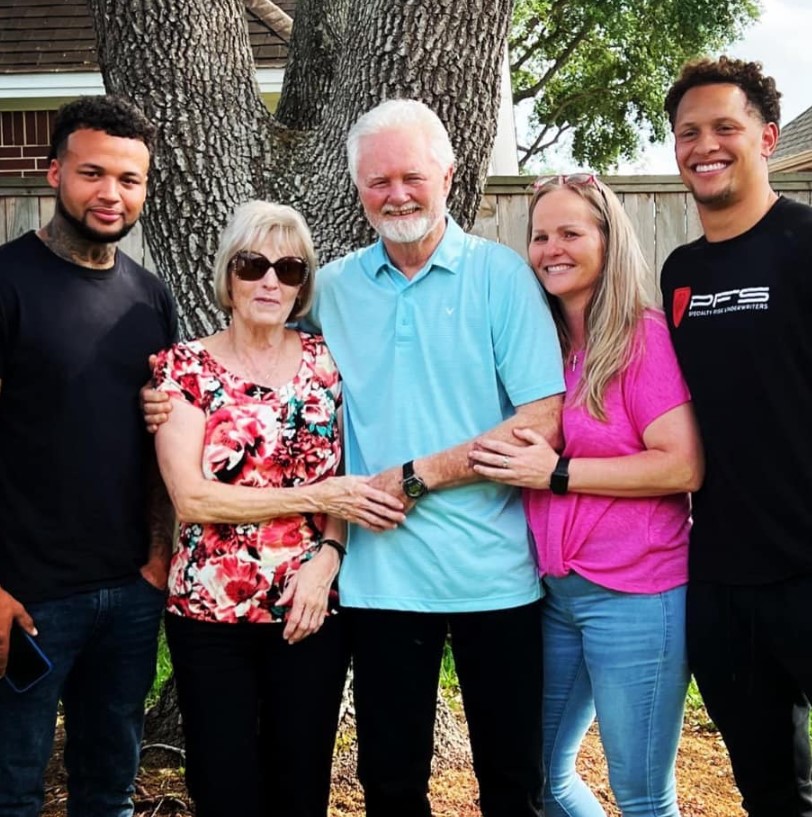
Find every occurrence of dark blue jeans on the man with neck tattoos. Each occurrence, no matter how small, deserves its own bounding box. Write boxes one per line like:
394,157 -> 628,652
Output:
0,577 -> 165,817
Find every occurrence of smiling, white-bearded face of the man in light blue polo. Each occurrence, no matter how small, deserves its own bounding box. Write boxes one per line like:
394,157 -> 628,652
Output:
356,127 -> 453,244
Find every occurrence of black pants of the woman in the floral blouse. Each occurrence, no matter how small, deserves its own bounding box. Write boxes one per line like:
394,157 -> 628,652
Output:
166,614 -> 347,817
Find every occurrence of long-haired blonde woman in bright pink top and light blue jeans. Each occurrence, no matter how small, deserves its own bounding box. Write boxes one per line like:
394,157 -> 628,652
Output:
471,174 -> 704,817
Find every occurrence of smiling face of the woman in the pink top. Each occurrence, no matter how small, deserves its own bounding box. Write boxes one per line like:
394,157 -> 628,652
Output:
528,187 -> 604,309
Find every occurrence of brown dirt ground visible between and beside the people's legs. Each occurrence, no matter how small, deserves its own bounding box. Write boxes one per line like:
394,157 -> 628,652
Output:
43,710 -> 744,817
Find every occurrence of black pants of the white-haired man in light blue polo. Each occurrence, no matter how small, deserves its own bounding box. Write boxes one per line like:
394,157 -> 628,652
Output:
344,602 -> 543,817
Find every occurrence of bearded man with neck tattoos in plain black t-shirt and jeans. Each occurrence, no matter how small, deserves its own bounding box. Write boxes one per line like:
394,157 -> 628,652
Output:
0,97 -> 177,817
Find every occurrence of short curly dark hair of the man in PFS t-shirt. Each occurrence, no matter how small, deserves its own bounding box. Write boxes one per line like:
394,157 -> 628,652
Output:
664,56 -> 781,130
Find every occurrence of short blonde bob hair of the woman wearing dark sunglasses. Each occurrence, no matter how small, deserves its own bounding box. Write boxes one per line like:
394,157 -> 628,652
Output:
214,201 -> 318,318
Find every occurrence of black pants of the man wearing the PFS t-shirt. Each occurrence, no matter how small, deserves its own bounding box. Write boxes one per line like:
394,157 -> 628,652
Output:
687,577 -> 812,817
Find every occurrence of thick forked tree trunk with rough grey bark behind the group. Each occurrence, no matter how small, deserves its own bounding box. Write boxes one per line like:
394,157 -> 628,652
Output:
88,0 -> 512,336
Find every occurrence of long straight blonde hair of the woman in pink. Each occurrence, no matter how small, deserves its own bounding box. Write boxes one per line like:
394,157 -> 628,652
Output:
527,174 -> 651,421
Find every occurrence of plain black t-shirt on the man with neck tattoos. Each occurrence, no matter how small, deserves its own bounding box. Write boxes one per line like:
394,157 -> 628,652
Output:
0,232 -> 177,603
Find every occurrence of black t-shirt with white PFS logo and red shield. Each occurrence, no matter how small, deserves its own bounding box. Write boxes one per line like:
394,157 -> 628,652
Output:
662,198 -> 812,584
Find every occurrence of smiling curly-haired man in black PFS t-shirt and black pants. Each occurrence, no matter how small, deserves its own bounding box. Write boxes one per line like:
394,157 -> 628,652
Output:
662,57 -> 812,817
